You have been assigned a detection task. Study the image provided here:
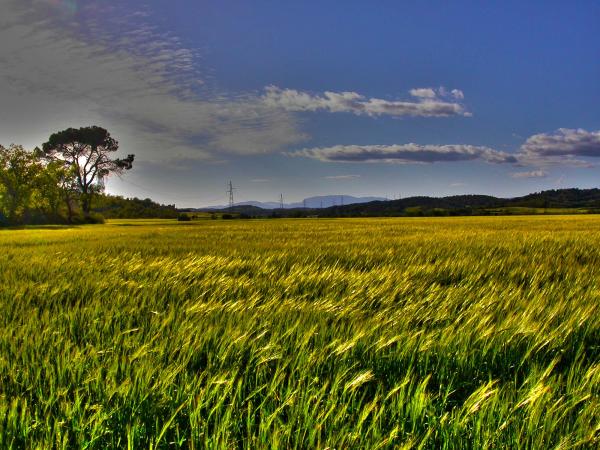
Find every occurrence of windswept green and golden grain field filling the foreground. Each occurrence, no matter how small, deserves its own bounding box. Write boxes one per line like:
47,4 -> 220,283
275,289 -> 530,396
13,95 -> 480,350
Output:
0,216 -> 600,449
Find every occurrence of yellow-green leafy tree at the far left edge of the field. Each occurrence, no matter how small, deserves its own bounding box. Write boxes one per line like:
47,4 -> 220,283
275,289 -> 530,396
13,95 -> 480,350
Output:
0,144 -> 44,224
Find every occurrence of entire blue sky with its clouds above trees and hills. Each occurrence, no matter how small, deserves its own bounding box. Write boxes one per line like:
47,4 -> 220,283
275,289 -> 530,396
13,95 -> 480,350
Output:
0,0 -> 600,206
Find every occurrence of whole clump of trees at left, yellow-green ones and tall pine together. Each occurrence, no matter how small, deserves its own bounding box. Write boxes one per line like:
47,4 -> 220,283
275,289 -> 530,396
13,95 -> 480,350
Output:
0,126 -> 134,225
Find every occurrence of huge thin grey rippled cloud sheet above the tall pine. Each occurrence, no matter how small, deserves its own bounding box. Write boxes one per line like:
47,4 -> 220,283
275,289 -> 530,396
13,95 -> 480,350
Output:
0,0 -> 305,161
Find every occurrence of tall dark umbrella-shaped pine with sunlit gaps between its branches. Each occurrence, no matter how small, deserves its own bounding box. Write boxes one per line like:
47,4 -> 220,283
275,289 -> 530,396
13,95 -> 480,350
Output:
42,126 -> 134,216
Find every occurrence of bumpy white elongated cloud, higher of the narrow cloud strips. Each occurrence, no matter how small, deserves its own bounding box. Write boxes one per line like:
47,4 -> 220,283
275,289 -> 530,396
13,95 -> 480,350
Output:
262,86 -> 471,117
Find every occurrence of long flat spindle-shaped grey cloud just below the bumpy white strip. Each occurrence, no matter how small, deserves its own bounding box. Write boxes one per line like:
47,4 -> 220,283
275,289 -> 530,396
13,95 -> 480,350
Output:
290,144 -> 517,164
